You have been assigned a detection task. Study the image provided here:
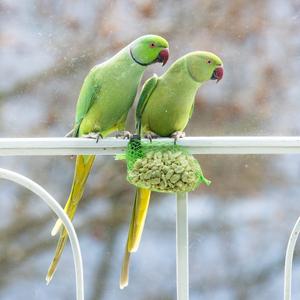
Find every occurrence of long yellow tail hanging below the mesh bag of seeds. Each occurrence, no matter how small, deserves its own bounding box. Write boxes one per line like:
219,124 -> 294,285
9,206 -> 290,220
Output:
120,188 -> 151,289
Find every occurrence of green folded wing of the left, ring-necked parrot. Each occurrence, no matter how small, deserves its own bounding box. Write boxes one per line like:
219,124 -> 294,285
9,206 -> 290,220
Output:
73,66 -> 101,136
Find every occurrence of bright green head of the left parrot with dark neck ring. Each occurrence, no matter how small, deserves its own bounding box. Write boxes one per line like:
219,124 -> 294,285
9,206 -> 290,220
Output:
129,35 -> 169,66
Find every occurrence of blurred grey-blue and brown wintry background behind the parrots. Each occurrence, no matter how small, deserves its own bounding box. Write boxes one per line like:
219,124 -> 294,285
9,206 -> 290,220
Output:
0,0 -> 300,300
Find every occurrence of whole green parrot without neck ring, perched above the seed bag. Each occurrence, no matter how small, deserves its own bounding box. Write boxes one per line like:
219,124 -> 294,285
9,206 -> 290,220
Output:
120,51 -> 223,289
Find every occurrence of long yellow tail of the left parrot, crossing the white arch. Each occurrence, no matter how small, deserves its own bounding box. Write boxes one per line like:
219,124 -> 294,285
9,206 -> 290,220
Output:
46,155 -> 95,283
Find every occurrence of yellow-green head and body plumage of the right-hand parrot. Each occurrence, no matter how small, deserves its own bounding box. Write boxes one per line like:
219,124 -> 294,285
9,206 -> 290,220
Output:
137,51 -> 222,137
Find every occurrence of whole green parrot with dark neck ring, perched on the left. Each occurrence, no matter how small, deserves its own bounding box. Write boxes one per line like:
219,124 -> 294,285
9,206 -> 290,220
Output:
46,35 -> 169,283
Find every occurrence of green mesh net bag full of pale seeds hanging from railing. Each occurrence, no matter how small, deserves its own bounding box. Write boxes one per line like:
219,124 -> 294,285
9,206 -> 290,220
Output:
117,138 -> 211,193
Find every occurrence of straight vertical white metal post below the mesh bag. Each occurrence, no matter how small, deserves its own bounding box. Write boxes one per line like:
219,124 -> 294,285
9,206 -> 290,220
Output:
176,193 -> 189,300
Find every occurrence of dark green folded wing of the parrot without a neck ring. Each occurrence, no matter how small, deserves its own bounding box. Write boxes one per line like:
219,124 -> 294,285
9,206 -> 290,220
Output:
135,74 -> 158,134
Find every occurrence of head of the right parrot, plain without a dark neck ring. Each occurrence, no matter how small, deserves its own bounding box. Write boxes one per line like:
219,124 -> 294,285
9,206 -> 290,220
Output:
186,51 -> 224,82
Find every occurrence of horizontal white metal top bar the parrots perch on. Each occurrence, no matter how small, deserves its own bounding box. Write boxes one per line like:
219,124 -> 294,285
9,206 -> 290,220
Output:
0,136 -> 300,156
